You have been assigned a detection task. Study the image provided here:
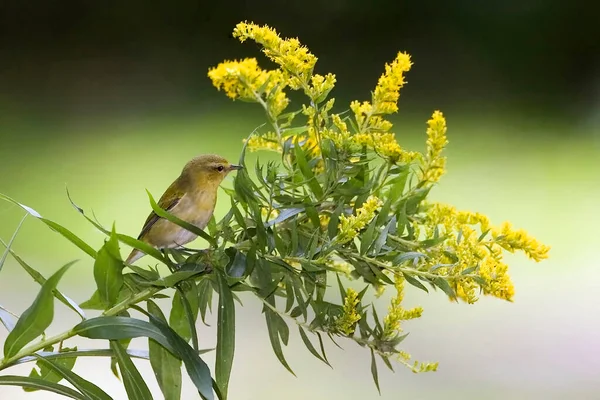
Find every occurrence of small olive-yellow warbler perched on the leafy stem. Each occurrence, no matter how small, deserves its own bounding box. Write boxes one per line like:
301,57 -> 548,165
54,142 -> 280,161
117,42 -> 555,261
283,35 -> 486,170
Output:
125,154 -> 242,264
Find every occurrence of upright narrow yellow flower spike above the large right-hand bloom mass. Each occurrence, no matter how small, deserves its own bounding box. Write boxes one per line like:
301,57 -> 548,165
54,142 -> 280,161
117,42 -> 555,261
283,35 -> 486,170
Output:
423,111 -> 448,183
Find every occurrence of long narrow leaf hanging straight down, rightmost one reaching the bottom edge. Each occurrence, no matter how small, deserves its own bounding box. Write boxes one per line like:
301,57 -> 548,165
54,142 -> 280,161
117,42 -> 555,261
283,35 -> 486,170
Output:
215,272 -> 235,399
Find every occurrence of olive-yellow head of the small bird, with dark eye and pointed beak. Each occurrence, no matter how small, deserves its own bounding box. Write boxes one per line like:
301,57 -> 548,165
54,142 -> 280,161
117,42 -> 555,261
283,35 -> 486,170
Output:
182,154 -> 242,188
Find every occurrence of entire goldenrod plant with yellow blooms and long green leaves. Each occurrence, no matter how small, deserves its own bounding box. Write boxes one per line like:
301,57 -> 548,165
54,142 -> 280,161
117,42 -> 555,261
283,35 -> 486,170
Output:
0,22 -> 549,400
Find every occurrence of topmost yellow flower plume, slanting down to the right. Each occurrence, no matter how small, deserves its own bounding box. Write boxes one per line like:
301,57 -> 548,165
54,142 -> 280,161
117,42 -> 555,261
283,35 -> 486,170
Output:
233,22 -> 318,94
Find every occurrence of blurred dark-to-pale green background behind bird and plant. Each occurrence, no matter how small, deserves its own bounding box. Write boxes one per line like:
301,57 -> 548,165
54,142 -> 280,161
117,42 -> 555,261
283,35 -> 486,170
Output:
0,0 -> 600,400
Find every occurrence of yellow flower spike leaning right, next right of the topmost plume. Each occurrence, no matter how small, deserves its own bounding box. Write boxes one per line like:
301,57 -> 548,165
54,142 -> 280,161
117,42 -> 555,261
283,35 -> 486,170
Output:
373,52 -> 412,114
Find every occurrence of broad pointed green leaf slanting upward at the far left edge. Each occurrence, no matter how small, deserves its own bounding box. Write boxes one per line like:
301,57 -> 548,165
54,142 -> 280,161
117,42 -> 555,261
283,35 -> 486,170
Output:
4,261 -> 75,358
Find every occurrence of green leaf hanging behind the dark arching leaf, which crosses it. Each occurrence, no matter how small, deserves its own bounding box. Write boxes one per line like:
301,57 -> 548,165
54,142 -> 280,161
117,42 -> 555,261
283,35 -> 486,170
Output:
148,301 -> 182,400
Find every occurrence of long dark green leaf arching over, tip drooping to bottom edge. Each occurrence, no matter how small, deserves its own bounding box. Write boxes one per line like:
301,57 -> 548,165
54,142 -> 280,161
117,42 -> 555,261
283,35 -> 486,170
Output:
73,315 -> 214,400
